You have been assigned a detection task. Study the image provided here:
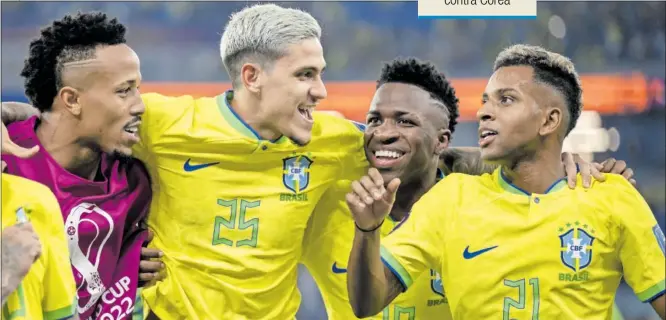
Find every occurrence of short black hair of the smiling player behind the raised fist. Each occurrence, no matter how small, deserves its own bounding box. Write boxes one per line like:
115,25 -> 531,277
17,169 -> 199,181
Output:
377,58 -> 459,133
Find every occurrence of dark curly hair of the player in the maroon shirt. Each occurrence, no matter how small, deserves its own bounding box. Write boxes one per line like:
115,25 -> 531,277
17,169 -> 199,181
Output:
21,12 -> 125,112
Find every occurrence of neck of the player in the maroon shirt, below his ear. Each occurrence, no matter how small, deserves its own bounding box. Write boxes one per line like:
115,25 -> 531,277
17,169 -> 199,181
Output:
36,112 -> 102,181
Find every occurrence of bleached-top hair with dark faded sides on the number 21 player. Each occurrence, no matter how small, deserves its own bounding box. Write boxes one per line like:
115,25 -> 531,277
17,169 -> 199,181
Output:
493,44 -> 583,134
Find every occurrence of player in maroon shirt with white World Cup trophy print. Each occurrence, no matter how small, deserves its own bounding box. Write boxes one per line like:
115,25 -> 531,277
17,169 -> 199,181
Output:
2,13 -> 151,319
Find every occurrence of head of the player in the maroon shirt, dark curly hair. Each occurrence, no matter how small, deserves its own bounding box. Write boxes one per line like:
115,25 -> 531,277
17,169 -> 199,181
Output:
21,13 -> 138,157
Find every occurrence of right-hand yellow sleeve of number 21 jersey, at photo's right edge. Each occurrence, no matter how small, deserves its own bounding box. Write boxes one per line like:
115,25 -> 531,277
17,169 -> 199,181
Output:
606,176 -> 666,302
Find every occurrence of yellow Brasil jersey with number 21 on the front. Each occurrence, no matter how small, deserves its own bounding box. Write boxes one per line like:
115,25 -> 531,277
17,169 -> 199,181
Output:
381,169 -> 666,320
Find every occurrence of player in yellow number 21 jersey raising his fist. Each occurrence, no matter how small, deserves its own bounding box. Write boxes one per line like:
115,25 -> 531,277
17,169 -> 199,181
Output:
347,45 -> 666,320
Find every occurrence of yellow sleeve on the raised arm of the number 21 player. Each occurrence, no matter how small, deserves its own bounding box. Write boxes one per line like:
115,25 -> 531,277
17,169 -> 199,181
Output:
380,175 -> 458,289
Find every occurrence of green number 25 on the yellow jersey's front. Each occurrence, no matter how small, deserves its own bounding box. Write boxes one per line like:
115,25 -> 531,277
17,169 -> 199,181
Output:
213,199 -> 261,248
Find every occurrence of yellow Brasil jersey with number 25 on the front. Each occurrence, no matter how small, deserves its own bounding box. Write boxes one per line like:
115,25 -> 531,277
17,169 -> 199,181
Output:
134,92 -> 367,320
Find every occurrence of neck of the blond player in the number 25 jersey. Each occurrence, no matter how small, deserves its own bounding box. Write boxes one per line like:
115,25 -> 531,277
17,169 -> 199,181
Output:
229,90 -> 281,140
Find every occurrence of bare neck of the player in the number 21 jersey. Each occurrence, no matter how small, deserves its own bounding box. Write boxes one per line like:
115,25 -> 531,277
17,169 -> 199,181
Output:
502,150 -> 564,194
